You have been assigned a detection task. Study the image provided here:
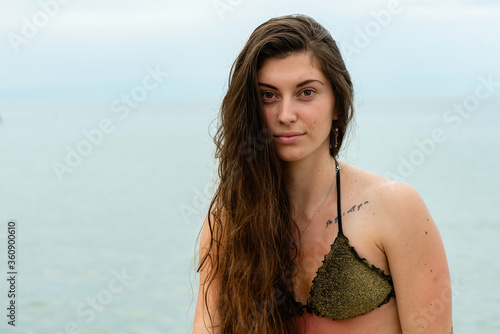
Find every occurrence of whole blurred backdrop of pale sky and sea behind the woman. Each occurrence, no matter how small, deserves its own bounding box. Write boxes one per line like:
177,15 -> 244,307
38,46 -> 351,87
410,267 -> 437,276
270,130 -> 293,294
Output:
0,0 -> 500,334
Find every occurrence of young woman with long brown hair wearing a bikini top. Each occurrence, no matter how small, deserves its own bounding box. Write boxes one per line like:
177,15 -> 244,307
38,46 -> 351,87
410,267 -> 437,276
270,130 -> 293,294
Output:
193,15 -> 453,334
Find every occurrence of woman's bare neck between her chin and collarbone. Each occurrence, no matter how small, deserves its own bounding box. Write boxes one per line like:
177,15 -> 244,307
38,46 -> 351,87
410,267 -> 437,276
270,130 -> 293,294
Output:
286,147 -> 335,221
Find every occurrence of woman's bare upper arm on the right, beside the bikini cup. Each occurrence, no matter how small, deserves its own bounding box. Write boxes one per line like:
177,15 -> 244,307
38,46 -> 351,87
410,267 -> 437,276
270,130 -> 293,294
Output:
382,183 -> 452,334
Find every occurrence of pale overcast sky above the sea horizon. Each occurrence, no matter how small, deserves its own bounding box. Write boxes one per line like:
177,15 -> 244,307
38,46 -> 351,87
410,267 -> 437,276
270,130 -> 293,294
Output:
0,0 -> 500,102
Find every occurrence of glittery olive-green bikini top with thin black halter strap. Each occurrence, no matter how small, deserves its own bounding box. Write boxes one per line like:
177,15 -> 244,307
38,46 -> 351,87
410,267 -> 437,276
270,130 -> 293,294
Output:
297,160 -> 395,320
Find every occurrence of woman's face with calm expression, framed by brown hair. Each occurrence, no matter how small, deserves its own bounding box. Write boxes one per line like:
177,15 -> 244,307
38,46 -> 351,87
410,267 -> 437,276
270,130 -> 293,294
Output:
258,53 -> 337,162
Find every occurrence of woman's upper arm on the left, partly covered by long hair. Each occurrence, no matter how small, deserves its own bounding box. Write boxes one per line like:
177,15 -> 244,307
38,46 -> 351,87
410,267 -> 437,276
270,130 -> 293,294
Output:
193,216 -> 218,334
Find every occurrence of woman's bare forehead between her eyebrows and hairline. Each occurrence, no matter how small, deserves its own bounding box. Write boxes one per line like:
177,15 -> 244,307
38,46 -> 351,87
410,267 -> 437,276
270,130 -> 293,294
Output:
257,53 -> 327,83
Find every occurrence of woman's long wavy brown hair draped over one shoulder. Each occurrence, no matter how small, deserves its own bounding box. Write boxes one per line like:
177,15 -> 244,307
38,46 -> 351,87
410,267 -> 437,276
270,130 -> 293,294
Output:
197,15 -> 354,334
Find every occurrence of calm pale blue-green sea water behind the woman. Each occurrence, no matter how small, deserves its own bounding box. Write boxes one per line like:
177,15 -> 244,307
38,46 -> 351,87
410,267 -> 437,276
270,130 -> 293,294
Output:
0,96 -> 500,334
